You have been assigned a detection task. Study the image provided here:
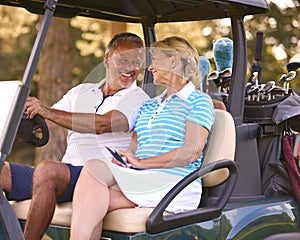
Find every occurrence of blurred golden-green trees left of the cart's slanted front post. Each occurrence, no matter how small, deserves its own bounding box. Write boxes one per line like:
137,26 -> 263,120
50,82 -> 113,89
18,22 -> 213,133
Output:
0,6 -> 38,80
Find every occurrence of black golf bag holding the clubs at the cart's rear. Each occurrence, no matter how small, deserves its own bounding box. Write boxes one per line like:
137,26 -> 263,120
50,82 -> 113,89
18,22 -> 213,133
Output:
244,91 -> 300,196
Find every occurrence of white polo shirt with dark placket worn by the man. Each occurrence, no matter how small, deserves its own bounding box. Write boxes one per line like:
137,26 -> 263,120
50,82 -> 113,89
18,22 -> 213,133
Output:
53,80 -> 149,166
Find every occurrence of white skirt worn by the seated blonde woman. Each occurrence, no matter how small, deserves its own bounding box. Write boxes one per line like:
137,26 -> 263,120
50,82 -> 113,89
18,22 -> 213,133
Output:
86,161 -> 202,212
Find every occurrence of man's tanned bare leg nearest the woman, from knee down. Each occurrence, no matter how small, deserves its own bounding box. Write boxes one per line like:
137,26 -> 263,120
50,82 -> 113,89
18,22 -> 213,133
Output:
24,160 -> 70,240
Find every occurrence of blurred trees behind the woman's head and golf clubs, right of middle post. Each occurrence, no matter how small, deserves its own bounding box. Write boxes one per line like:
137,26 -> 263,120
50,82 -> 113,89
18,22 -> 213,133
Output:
148,0 -> 300,94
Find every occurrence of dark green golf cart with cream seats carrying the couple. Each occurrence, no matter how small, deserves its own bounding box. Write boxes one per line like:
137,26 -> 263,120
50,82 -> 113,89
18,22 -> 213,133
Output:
0,0 -> 300,240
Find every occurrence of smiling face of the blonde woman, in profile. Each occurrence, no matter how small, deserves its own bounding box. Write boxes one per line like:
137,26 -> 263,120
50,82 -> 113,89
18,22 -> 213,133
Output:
148,49 -> 174,86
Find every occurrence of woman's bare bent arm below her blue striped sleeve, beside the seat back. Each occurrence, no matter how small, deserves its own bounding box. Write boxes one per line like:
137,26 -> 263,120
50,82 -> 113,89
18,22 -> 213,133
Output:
120,121 -> 208,168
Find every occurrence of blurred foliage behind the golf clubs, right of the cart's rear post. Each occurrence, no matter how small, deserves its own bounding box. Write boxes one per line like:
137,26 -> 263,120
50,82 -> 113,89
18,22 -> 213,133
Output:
245,3 -> 300,93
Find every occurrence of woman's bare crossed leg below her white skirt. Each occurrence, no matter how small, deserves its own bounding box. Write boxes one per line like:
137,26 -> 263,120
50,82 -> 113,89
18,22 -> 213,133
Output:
70,160 -> 135,240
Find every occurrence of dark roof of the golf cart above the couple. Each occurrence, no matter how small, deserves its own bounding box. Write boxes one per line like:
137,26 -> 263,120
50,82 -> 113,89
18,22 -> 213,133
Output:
0,0 -> 268,23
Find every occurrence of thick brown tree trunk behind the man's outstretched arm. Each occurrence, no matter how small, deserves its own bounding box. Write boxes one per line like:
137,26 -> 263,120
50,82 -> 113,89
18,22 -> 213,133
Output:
35,18 -> 72,164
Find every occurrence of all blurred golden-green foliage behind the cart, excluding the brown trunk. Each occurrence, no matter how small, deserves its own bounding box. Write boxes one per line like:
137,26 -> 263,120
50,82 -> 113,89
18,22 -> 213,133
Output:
0,1 -> 300,92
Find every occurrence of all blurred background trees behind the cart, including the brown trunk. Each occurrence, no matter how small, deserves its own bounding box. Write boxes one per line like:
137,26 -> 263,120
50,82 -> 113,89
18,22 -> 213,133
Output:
0,0 -> 300,165
